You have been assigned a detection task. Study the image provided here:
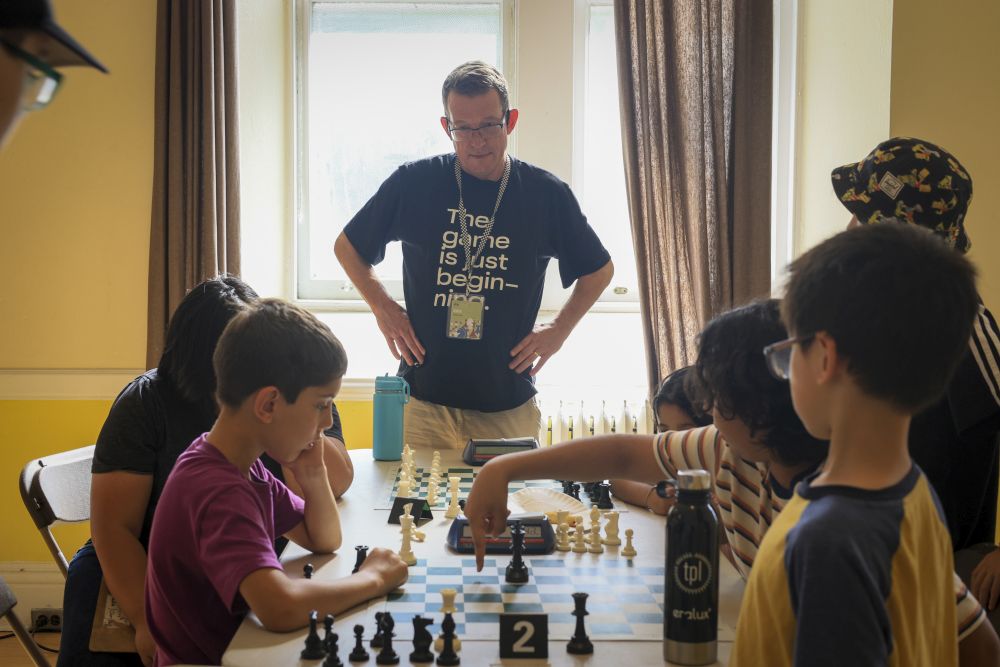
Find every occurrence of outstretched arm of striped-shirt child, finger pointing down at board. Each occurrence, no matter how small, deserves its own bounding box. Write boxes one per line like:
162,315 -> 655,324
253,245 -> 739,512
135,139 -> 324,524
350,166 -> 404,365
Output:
465,435 -> 663,569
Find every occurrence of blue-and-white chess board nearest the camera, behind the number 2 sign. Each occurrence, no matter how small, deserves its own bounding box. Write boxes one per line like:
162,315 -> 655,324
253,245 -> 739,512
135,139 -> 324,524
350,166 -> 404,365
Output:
337,553 -> 735,641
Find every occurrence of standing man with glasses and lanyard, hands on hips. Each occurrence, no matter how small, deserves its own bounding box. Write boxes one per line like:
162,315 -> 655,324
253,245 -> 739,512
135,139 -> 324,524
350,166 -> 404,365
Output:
334,61 -> 614,448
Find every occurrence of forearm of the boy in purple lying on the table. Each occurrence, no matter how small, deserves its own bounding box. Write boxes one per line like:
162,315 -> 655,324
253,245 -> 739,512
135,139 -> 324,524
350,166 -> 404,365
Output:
240,548 -> 407,632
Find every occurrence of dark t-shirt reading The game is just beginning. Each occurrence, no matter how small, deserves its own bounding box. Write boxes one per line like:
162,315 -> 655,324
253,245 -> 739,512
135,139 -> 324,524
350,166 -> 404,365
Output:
344,154 -> 610,412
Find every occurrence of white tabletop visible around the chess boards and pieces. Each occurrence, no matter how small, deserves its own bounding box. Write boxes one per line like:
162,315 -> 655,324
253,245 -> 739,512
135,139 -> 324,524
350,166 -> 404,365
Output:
222,449 -> 743,667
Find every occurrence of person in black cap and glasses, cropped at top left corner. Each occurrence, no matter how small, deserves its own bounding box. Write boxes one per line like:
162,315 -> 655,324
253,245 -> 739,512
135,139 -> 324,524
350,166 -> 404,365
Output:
0,0 -> 107,148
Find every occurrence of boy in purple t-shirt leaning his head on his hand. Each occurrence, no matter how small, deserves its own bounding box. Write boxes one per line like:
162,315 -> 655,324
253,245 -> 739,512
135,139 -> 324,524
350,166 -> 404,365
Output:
146,299 -> 406,665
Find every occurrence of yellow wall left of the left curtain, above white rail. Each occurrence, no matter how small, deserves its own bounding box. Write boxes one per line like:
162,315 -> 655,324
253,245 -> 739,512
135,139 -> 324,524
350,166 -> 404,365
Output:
0,0 -> 156,368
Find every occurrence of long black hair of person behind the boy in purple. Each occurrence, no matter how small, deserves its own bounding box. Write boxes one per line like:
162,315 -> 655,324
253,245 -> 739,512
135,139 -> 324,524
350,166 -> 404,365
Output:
156,274 -> 257,416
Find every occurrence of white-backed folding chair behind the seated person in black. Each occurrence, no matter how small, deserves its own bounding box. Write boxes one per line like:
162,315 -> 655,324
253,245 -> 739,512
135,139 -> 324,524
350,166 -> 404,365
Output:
21,445 -> 94,577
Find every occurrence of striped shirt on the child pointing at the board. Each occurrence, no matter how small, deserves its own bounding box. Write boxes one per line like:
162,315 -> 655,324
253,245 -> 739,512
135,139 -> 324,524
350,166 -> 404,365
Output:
653,425 -> 986,641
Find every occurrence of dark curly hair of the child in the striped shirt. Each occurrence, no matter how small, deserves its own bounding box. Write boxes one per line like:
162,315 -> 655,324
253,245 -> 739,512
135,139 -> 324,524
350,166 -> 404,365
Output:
688,299 -> 829,466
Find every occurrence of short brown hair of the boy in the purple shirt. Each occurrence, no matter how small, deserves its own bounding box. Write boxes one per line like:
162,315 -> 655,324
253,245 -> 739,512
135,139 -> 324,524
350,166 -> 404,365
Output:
214,299 -> 347,408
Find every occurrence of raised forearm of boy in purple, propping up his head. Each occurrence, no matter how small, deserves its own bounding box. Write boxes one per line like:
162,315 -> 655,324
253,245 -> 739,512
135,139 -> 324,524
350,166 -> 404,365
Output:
286,444 -> 343,553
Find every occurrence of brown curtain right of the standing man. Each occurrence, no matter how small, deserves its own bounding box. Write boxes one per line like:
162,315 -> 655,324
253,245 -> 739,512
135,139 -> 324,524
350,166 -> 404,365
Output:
615,0 -> 772,389
